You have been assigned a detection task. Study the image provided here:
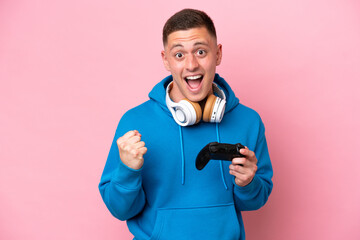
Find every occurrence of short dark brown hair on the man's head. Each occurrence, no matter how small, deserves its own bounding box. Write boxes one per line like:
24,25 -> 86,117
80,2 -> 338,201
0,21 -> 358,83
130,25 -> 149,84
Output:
163,8 -> 216,46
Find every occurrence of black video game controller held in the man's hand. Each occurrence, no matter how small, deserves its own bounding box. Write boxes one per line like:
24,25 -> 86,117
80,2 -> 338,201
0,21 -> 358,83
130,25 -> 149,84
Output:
195,142 -> 245,170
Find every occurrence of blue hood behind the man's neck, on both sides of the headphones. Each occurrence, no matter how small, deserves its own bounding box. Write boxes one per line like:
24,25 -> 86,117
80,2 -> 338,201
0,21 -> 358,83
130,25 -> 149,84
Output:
149,73 -> 239,115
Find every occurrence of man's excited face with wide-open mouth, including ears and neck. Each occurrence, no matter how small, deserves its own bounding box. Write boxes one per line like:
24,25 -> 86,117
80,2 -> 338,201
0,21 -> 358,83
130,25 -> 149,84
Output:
161,27 -> 222,102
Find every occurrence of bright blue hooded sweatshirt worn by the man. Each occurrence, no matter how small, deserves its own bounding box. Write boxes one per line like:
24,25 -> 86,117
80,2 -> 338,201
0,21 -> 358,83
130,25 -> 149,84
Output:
99,74 -> 273,240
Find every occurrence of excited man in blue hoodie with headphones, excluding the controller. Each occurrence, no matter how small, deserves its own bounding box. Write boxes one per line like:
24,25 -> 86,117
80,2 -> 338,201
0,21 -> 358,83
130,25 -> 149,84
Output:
99,9 -> 272,240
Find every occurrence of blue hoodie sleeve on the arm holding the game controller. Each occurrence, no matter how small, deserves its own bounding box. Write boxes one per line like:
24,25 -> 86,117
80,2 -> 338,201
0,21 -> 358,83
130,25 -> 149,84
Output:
233,119 -> 273,211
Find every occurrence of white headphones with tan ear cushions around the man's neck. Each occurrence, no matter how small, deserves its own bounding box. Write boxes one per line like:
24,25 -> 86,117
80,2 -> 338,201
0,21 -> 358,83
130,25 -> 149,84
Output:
166,82 -> 226,126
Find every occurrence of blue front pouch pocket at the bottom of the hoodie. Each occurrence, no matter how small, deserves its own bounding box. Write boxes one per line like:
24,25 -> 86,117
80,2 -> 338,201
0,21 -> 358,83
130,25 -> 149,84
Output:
150,204 -> 240,240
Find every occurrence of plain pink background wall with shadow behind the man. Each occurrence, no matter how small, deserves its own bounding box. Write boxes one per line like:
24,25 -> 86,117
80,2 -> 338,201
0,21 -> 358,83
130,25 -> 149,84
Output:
0,0 -> 360,240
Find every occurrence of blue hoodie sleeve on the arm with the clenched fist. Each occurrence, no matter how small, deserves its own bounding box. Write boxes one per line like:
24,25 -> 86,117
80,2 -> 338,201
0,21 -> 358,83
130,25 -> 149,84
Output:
99,117 -> 145,221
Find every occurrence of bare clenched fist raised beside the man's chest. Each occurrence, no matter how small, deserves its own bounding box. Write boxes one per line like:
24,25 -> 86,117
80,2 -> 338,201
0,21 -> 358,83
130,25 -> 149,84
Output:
116,130 -> 147,170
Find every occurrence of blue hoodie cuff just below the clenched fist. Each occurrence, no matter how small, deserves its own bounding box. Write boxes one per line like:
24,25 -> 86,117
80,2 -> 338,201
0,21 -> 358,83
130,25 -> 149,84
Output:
112,160 -> 142,189
